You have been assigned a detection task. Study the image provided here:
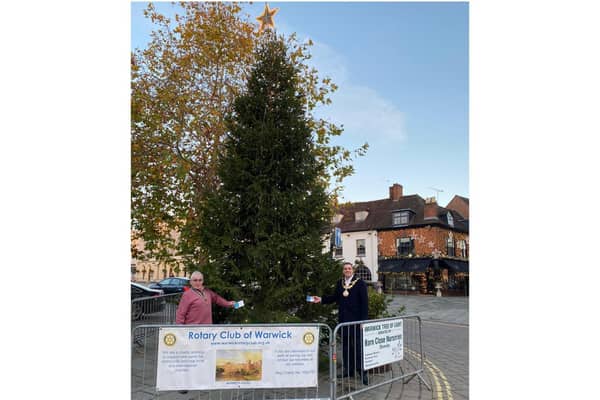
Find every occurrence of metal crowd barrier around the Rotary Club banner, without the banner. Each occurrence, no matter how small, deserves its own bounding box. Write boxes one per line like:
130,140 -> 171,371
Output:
131,323 -> 331,400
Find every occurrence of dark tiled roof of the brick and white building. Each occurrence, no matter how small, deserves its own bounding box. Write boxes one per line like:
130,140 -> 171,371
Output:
335,194 -> 469,232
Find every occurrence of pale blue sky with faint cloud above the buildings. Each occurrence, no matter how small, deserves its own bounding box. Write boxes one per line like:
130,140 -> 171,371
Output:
131,2 -> 469,205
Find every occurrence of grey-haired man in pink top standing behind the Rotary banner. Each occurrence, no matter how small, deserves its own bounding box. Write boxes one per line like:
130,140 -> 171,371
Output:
175,271 -> 235,324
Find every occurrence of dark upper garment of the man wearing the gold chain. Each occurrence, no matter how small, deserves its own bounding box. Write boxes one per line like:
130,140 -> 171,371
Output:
321,277 -> 369,323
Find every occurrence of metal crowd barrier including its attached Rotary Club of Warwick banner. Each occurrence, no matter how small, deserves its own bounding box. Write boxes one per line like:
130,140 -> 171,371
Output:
131,324 -> 331,400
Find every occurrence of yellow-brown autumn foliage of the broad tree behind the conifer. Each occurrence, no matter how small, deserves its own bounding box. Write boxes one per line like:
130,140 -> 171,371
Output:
131,2 -> 367,266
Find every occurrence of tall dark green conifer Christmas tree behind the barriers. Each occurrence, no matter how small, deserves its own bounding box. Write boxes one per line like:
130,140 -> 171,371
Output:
197,32 -> 339,322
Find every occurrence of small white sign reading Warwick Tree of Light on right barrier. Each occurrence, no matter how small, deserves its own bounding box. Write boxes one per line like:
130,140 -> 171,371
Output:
362,319 -> 404,370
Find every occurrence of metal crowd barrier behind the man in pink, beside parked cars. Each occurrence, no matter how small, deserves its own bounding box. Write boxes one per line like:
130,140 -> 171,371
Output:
131,293 -> 183,347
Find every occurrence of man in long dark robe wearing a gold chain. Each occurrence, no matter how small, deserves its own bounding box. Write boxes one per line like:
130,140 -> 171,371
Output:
314,262 -> 369,385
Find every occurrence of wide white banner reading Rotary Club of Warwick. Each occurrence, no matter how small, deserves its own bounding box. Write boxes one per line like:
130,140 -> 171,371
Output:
156,326 -> 319,391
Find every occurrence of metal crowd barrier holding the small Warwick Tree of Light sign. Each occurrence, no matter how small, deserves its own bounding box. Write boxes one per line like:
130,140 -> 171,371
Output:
330,315 -> 431,400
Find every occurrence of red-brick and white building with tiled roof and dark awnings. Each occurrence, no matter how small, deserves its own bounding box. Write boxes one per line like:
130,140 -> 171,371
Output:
334,184 -> 469,295
